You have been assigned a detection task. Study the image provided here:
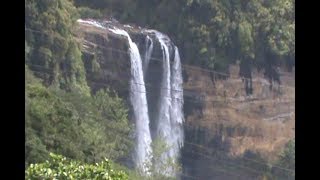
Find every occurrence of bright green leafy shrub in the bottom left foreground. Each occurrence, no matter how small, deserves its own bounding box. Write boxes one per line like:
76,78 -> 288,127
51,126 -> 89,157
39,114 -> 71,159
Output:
25,153 -> 128,180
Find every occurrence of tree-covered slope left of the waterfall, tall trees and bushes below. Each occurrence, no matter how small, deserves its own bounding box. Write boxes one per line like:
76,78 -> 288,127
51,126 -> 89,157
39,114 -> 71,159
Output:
25,0 -> 133,172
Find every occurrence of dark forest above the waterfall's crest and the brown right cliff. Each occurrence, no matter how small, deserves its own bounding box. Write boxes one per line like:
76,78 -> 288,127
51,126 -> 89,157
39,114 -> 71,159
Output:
75,0 -> 295,79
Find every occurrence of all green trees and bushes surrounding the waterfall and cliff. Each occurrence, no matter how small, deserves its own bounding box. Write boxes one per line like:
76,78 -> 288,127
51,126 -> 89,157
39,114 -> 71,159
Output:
25,0 -> 295,179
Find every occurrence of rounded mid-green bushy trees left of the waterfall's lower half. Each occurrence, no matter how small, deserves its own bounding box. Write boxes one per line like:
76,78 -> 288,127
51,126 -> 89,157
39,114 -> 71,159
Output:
25,69 -> 133,167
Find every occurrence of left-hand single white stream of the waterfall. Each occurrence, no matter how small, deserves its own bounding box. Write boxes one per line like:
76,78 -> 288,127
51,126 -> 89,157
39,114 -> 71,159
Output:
110,29 -> 152,173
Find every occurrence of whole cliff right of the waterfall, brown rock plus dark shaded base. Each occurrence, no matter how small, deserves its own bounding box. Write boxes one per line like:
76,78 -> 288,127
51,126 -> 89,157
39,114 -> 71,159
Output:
183,65 -> 295,179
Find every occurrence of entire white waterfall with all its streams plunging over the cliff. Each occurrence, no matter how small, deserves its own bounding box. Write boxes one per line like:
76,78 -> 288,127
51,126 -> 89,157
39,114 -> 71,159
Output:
78,20 -> 184,176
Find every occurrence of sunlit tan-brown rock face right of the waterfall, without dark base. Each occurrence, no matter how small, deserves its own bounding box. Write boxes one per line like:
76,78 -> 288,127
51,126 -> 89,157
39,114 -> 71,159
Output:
184,65 -> 295,159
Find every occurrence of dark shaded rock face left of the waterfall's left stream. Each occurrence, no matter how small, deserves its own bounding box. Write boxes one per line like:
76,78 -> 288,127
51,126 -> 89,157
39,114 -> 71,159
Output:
76,23 -> 130,97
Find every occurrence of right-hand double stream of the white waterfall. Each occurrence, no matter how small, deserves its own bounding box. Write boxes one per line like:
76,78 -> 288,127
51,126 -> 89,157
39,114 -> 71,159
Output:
152,31 -> 184,176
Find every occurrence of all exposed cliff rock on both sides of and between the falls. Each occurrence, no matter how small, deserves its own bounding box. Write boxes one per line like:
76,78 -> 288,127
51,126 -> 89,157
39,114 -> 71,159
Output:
75,20 -> 295,179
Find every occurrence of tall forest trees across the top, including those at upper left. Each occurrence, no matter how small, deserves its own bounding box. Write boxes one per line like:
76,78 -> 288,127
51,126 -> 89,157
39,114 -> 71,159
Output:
25,0 -> 295,90
